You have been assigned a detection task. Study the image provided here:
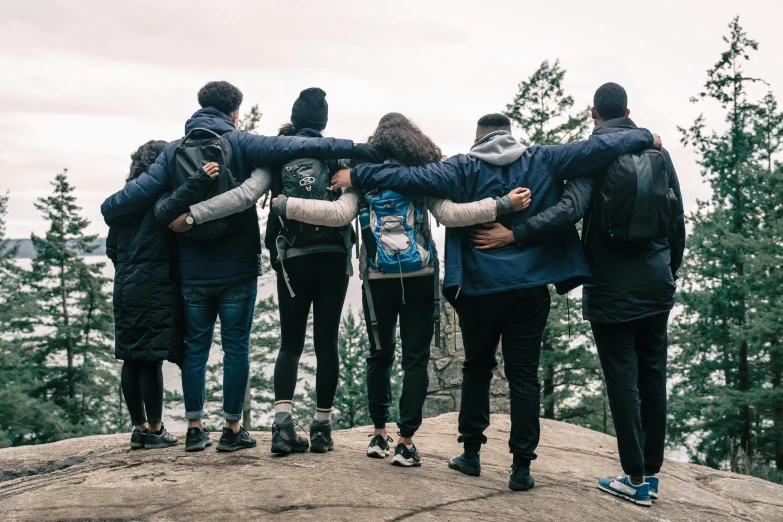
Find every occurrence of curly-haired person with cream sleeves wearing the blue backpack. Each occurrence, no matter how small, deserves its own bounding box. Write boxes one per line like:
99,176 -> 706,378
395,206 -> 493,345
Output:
270,113 -> 530,467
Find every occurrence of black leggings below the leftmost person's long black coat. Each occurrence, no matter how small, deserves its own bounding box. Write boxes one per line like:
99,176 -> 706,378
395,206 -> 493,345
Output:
122,361 -> 163,426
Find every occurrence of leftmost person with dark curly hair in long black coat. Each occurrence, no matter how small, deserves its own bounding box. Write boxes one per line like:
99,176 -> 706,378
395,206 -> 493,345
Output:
106,140 -> 217,449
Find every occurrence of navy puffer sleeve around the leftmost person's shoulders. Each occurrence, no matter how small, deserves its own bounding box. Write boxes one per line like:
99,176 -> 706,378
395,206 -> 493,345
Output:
101,148 -> 169,224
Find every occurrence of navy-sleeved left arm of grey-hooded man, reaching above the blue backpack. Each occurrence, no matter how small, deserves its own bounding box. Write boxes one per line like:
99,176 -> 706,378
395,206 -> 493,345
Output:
348,155 -> 469,201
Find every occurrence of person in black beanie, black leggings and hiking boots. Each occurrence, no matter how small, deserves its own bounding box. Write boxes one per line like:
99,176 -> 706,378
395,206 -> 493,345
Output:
265,87 -> 353,454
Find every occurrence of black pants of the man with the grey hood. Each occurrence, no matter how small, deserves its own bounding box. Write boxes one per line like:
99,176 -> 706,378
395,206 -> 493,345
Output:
444,286 -> 550,460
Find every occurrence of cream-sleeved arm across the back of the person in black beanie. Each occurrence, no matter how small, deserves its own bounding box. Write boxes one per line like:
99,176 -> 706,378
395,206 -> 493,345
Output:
272,189 -> 361,227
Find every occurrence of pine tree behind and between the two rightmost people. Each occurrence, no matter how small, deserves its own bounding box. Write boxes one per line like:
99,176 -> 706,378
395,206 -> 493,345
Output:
504,60 -> 602,423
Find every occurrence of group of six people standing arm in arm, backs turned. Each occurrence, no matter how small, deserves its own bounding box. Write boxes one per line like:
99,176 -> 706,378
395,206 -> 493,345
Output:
101,82 -> 685,505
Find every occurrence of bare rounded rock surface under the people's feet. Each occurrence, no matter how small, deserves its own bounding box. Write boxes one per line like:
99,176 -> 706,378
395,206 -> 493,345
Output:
0,413 -> 783,522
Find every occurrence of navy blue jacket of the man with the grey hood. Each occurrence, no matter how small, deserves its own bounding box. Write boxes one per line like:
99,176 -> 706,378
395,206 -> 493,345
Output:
351,130 -> 653,295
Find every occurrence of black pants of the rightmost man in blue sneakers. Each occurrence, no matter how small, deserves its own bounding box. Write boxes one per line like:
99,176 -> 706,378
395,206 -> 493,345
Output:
591,312 -> 669,476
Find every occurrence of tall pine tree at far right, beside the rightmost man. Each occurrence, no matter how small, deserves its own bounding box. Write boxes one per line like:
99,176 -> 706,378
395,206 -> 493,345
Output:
670,18 -> 783,478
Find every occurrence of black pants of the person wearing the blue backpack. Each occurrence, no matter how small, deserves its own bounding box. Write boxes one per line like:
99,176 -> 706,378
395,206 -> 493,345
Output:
362,276 -> 435,437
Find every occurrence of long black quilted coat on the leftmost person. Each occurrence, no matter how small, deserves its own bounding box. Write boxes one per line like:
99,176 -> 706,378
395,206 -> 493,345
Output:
106,201 -> 184,364
